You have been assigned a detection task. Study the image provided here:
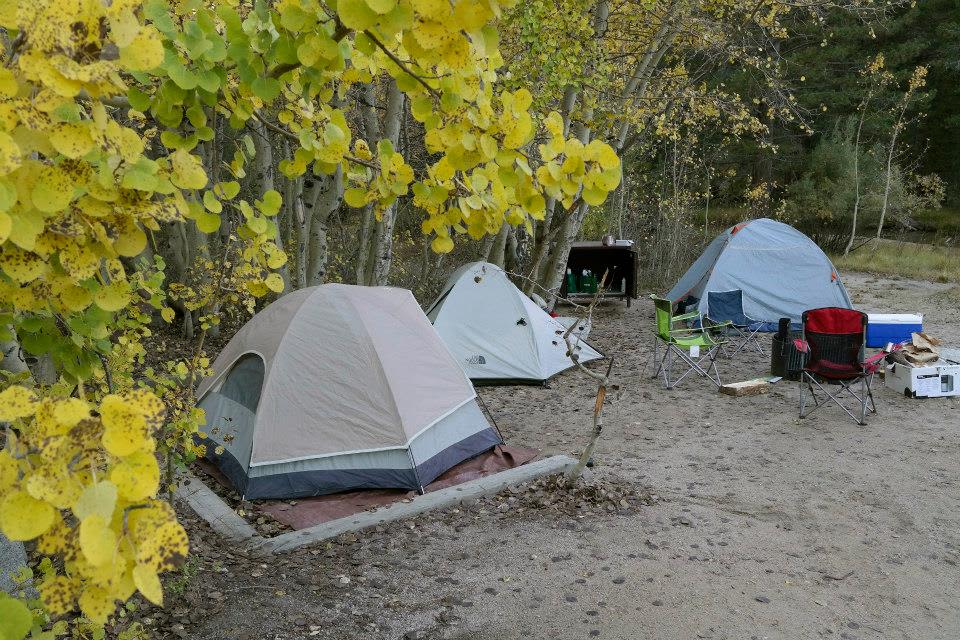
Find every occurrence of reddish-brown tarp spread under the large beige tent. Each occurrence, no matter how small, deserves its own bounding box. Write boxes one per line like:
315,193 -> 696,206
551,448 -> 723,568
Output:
195,445 -> 539,529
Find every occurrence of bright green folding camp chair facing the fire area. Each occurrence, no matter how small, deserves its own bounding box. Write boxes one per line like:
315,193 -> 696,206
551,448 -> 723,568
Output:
650,295 -> 723,389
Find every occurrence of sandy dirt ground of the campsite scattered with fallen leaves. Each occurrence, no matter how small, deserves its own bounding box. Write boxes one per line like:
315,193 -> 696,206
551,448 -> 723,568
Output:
158,274 -> 960,640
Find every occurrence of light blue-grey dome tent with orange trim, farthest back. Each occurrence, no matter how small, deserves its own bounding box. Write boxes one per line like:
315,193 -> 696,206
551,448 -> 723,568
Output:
666,218 -> 852,323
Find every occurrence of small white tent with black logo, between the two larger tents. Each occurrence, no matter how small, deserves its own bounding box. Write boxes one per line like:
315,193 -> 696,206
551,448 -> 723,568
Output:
427,262 -> 603,384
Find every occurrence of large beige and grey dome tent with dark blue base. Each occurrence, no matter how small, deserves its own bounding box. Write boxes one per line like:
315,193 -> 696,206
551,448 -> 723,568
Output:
197,284 -> 502,499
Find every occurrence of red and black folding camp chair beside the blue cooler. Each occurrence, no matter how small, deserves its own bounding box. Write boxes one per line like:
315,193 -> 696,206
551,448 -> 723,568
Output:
794,307 -> 886,425
